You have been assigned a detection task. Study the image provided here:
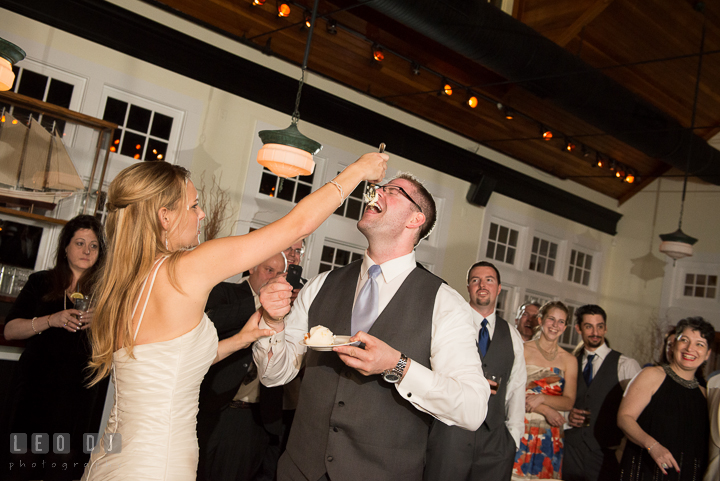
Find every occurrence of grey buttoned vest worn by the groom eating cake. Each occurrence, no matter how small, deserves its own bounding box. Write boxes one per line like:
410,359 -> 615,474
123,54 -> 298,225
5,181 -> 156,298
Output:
287,261 -> 442,481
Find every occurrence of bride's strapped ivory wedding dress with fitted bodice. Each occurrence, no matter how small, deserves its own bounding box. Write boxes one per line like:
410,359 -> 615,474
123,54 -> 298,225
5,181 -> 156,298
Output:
83,258 -> 218,481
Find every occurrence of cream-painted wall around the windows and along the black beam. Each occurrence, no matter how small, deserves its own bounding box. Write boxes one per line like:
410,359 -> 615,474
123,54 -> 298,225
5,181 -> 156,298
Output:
0,0 -> 720,364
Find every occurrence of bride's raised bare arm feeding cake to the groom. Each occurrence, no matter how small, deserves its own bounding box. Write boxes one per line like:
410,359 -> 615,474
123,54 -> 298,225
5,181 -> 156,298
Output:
188,152 -> 388,292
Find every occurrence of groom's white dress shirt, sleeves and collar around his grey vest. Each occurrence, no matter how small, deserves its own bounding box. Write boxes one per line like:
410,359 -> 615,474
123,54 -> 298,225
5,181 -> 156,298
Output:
253,252 -> 490,431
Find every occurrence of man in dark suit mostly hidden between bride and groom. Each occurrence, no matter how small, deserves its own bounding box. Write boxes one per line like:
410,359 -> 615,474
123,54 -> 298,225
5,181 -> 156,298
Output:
197,254 -> 285,481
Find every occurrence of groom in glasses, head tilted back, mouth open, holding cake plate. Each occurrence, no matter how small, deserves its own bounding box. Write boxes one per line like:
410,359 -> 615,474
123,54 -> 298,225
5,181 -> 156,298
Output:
253,174 -> 490,481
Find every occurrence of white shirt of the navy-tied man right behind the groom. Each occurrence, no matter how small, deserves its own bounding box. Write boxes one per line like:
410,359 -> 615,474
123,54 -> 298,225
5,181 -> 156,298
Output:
472,309 -> 527,448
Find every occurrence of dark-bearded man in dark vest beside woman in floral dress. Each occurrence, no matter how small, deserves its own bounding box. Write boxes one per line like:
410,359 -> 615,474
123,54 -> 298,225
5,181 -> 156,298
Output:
562,304 -> 640,481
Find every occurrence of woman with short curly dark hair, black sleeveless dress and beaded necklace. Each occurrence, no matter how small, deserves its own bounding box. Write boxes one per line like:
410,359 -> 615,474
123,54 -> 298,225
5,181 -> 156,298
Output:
618,317 -> 715,481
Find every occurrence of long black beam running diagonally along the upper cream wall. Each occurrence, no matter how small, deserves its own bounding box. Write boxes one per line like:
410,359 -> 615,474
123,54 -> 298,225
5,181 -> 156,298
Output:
0,0 -> 622,235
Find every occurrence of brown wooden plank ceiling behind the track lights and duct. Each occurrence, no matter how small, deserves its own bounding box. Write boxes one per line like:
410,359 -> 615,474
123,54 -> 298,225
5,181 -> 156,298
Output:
153,0 -> 720,202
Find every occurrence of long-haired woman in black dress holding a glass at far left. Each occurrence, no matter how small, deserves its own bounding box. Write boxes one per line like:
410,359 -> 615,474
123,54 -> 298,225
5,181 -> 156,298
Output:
2,215 -> 107,480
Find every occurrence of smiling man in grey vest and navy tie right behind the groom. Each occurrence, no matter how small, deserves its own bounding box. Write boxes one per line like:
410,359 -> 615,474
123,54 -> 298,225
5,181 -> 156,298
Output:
424,261 -> 527,481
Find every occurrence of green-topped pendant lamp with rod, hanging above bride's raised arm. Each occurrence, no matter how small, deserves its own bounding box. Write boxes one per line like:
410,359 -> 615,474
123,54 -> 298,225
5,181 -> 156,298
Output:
257,0 -> 322,178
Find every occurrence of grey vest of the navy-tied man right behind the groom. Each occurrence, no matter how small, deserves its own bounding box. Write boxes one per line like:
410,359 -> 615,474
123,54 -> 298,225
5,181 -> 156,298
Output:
478,316 -> 515,429
